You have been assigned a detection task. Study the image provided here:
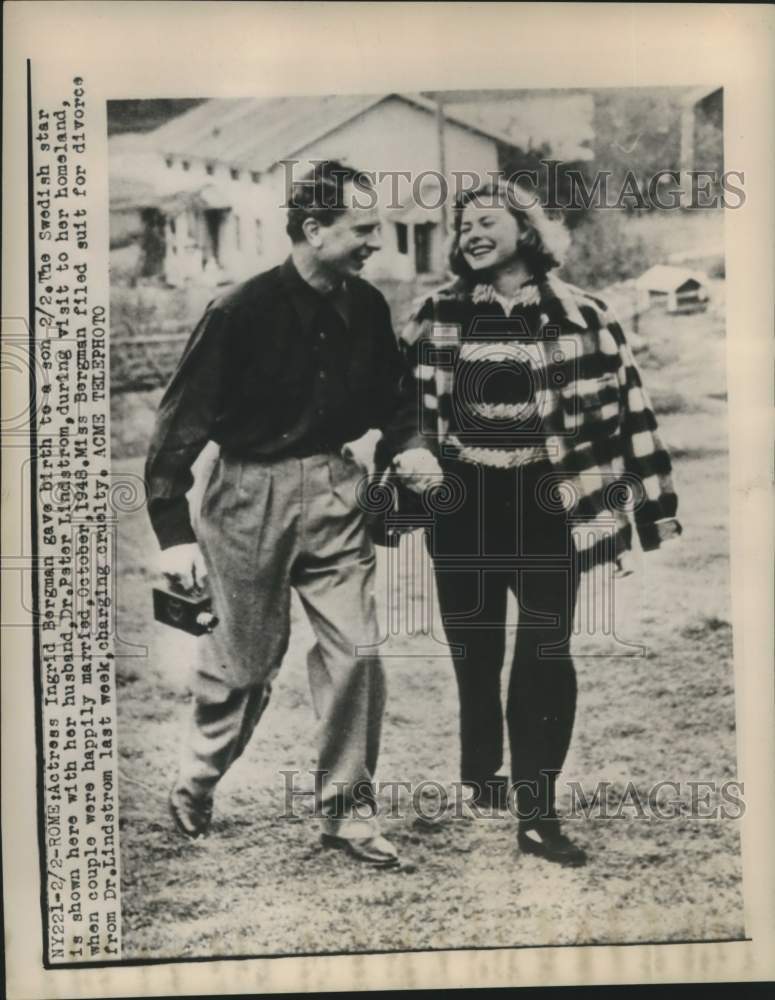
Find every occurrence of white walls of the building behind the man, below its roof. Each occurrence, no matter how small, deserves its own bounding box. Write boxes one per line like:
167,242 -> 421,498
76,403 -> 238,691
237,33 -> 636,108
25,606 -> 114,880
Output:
110,98 -> 504,285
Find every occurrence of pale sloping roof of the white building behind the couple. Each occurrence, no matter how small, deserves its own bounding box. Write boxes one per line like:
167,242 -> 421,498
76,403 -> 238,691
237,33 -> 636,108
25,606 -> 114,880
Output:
147,94 -> 513,171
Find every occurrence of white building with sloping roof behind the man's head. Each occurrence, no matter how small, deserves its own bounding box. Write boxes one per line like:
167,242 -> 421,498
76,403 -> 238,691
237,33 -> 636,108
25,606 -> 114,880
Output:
109,94 -> 515,286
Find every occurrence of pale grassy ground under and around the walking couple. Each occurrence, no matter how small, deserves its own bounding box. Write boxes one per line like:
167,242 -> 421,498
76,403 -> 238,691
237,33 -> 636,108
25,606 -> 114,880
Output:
113,283 -> 744,959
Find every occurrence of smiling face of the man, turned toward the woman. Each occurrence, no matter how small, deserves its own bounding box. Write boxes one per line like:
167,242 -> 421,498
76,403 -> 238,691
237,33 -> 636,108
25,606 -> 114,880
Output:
315,184 -> 382,278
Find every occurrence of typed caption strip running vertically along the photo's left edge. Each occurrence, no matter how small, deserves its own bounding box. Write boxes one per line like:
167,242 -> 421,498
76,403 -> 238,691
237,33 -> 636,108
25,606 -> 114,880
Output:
25,65 -> 121,965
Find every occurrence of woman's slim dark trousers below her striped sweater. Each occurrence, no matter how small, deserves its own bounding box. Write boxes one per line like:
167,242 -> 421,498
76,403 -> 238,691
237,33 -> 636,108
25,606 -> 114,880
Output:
429,461 -> 578,819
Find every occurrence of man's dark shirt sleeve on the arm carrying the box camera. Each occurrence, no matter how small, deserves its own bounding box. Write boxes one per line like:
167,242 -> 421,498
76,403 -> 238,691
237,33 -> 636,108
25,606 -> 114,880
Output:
145,307 -> 226,549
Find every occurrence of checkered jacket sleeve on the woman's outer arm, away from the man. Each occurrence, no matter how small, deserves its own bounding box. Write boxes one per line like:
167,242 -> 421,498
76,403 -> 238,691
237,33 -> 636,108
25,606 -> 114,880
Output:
605,313 -> 682,551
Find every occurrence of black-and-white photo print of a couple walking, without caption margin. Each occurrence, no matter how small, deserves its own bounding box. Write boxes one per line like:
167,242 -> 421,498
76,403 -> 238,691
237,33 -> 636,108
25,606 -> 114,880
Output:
108,86 -> 745,958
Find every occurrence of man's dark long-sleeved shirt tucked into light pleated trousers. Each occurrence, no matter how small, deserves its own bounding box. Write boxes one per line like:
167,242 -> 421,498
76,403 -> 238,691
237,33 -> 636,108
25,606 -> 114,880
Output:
145,250 -> 404,549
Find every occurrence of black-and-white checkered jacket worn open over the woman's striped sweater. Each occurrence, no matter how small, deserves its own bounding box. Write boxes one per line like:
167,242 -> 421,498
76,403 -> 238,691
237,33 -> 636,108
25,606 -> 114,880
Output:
378,276 -> 681,569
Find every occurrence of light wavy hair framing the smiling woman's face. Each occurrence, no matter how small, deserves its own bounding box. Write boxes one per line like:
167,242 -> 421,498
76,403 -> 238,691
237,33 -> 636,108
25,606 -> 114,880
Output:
449,179 -> 569,284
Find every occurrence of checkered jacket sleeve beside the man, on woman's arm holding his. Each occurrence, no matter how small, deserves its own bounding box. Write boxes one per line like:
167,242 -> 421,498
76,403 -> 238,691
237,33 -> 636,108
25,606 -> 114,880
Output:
382,299 -> 438,464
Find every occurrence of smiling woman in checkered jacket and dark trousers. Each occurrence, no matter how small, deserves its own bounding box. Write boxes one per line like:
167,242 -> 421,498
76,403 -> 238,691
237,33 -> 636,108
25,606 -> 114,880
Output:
385,183 -> 680,865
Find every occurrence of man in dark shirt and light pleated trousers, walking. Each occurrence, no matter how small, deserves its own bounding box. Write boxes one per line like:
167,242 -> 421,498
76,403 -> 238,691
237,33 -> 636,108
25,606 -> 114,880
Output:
146,161 -> 403,866
